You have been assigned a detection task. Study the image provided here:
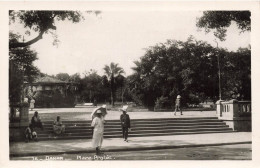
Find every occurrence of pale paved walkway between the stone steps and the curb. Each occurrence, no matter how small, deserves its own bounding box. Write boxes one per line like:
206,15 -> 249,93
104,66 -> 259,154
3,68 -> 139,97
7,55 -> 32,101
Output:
10,132 -> 252,157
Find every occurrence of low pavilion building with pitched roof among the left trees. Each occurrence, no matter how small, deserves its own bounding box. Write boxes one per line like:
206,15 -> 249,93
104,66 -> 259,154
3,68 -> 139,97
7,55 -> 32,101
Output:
24,76 -> 78,107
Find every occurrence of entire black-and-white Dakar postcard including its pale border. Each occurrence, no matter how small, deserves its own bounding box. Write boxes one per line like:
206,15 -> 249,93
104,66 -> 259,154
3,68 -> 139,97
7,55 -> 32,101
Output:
1,2 -> 259,166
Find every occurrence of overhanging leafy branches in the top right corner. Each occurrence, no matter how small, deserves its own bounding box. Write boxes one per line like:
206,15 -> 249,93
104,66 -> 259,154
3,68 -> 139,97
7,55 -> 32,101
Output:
197,11 -> 251,41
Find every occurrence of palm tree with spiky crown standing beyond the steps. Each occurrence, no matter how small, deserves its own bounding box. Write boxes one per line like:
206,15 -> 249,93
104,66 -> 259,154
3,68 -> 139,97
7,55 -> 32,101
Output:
104,62 -> 124,106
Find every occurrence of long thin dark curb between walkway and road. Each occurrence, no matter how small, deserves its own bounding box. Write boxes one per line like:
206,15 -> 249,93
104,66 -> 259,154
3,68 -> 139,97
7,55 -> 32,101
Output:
9,141 -> 252,157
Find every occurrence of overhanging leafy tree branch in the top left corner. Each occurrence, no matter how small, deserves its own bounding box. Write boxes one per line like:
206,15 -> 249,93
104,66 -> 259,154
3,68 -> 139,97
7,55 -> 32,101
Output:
9,10 -> 100,48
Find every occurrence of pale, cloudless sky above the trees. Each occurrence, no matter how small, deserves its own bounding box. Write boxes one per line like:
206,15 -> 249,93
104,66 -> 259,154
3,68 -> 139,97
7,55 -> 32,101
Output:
10,11 -> 250,75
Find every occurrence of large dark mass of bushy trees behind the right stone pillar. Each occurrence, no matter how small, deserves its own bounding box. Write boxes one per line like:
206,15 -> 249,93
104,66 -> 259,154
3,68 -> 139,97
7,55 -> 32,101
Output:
128,37 -> 251,108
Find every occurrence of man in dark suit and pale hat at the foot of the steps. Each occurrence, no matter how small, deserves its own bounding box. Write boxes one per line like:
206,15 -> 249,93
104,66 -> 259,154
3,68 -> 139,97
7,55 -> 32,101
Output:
120,106 -> 130,142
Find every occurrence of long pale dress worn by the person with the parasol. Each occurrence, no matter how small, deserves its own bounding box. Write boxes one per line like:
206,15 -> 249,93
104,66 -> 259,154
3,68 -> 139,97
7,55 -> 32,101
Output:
91,117 -> 105,148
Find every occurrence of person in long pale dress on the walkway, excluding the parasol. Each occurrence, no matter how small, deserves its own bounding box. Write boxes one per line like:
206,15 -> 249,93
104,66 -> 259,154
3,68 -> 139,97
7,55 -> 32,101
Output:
91,110 -> 105,155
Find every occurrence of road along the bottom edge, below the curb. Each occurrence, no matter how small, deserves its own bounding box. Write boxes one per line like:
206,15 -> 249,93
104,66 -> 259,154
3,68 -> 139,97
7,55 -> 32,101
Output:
10,144 -> 252,161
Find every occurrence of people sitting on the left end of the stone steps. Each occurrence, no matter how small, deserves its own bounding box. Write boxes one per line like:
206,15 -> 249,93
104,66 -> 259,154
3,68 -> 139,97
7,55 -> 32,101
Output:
24,111 -> 65,142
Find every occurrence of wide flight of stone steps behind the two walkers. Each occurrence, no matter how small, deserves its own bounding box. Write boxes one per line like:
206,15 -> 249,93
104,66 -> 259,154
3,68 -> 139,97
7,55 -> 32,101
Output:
37,117 -> 232,141
